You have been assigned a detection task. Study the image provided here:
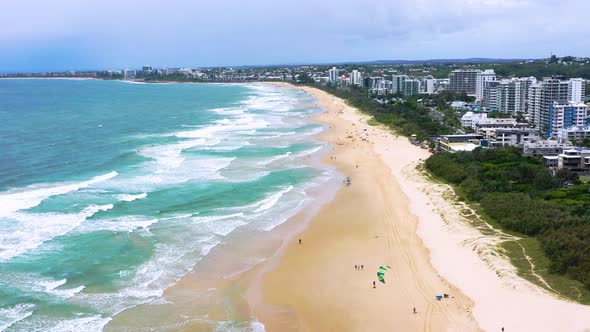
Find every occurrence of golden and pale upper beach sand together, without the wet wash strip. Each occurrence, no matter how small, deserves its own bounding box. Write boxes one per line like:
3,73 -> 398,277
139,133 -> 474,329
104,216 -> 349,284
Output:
251,85 -> 590,331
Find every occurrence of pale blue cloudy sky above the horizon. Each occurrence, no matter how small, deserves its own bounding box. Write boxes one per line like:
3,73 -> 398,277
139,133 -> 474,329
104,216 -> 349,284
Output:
0,0 -> 590,72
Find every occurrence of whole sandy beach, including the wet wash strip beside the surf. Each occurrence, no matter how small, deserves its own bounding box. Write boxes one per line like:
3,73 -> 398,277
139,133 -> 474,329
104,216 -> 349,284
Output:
106,82 -> 590,331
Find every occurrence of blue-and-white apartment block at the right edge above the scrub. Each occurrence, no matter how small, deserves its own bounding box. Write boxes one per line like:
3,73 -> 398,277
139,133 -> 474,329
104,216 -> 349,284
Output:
547,102 -> 588,137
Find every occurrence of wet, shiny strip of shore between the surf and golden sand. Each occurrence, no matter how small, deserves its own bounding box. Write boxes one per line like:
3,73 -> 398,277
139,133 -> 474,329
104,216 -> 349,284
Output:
104,83 -> 339,331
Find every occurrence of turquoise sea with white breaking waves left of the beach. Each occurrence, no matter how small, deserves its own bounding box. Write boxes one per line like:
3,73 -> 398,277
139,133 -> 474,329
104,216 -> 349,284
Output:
0,80 -> 332,331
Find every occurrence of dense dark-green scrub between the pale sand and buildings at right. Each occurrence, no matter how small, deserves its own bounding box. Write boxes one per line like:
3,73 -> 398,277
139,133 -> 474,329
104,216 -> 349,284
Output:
425,148 -> 590,290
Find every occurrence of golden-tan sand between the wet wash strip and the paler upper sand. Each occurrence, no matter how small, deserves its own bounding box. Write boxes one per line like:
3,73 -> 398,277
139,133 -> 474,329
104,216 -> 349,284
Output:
253,84 -> 479,331
